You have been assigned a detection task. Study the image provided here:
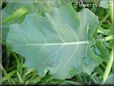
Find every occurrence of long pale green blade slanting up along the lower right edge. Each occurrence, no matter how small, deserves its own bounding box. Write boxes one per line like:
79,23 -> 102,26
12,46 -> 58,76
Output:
102,46 -> 114,83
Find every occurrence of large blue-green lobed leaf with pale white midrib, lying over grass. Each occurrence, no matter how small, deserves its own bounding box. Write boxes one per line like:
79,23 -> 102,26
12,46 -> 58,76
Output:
7,5 -> 101,79
